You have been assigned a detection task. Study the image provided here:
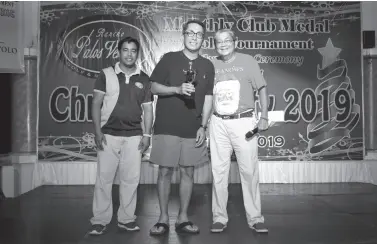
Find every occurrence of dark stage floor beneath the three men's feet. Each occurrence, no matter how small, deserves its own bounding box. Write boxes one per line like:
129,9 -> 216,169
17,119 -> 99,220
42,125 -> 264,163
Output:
0,183 -> 377,244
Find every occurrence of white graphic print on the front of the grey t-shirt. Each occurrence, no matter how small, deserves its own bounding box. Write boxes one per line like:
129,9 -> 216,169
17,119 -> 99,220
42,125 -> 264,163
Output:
213,79 -> 240,115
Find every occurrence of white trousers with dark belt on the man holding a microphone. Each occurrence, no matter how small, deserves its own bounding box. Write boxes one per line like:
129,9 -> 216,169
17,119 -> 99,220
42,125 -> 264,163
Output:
210,115 -> 264,227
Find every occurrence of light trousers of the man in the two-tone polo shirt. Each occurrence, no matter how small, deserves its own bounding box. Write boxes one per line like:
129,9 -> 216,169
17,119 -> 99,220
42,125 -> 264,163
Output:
90,135 -> 141,225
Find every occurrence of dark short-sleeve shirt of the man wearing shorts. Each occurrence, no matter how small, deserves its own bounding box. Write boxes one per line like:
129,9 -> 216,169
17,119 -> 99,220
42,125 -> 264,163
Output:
151,51 -> 214,138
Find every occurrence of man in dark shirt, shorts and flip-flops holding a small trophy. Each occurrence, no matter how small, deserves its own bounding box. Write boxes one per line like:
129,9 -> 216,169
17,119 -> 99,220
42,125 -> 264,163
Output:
150,20 -> 214,235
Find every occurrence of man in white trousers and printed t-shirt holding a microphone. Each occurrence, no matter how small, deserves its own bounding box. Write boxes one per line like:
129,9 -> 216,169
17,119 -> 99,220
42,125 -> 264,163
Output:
209,29 -> 268,233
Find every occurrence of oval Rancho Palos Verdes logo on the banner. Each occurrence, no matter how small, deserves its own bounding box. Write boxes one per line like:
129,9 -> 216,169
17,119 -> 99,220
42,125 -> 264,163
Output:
58,15 -> 151,78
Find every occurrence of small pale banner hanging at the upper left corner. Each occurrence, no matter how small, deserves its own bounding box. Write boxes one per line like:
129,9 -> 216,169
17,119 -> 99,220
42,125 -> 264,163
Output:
0,1 -> 25,73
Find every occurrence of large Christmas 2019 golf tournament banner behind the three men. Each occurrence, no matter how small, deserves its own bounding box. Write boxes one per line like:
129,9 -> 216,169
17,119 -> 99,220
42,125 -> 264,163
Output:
39,1 -> 363,161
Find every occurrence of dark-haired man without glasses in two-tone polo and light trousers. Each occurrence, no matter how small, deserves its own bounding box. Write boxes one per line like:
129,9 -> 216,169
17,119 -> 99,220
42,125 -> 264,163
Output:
89,37 -> 153,235
